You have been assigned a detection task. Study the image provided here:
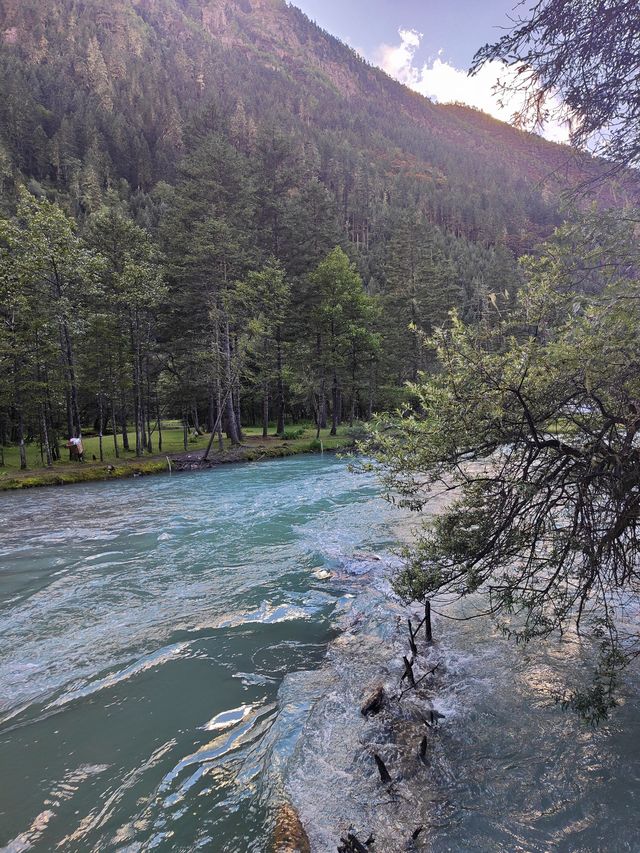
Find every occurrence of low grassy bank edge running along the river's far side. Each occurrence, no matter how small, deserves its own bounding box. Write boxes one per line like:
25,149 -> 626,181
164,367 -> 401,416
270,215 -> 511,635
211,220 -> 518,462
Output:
0,429 -> 354,491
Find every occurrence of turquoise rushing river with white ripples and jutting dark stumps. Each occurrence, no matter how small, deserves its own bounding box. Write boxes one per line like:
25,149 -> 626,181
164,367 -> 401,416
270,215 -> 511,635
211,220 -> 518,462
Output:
0,456 -> 640,853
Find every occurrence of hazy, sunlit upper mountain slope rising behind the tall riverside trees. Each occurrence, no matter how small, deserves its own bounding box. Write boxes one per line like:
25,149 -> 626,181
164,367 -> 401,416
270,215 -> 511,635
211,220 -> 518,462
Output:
0,0 -> 624,252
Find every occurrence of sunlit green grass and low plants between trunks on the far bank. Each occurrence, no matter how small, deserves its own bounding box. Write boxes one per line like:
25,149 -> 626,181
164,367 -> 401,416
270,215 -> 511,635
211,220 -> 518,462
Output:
0,425 -> 355,491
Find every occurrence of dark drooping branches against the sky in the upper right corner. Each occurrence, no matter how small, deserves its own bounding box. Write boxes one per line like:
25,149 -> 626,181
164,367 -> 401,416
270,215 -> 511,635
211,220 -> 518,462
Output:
472,0 -> 640,173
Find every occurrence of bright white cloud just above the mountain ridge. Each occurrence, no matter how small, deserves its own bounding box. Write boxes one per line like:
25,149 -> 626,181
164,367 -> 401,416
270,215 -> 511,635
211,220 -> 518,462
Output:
375,29 -> 569,142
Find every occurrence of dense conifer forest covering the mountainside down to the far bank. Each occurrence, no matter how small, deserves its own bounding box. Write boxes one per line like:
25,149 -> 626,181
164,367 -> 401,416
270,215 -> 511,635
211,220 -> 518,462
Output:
0,0 -> 624,464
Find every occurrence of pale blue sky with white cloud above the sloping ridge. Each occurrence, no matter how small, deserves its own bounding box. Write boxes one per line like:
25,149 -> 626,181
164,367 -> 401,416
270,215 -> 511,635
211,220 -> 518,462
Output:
292,0 -> 568,142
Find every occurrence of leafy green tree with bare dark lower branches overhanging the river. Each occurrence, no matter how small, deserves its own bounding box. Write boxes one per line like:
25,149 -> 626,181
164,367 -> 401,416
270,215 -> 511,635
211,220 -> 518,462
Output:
368,208 -> 640,719
